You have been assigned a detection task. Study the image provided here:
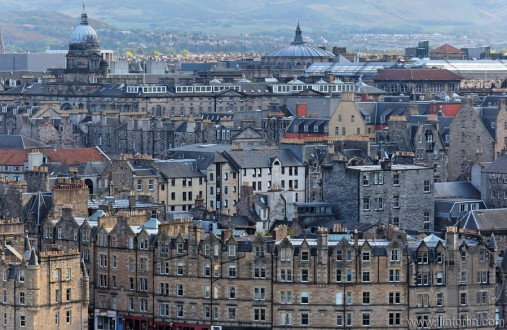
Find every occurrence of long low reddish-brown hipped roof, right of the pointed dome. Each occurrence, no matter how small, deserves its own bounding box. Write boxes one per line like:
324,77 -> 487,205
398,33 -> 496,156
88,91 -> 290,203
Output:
373,69 -> 463,81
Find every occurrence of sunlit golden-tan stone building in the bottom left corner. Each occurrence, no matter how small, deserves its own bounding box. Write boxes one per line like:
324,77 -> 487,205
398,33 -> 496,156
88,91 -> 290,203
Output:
0,221 -> 89,329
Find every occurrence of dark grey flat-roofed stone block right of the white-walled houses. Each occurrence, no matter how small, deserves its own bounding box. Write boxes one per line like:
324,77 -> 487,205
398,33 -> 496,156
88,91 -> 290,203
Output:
322,160 -> 434,230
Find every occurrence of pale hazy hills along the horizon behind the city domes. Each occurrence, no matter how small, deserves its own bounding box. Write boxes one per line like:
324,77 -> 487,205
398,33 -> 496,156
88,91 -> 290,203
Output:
0,0 -> 507,40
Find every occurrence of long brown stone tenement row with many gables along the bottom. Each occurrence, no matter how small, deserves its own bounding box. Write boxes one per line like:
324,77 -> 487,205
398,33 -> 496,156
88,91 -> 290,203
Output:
41,205 -> 497,329
